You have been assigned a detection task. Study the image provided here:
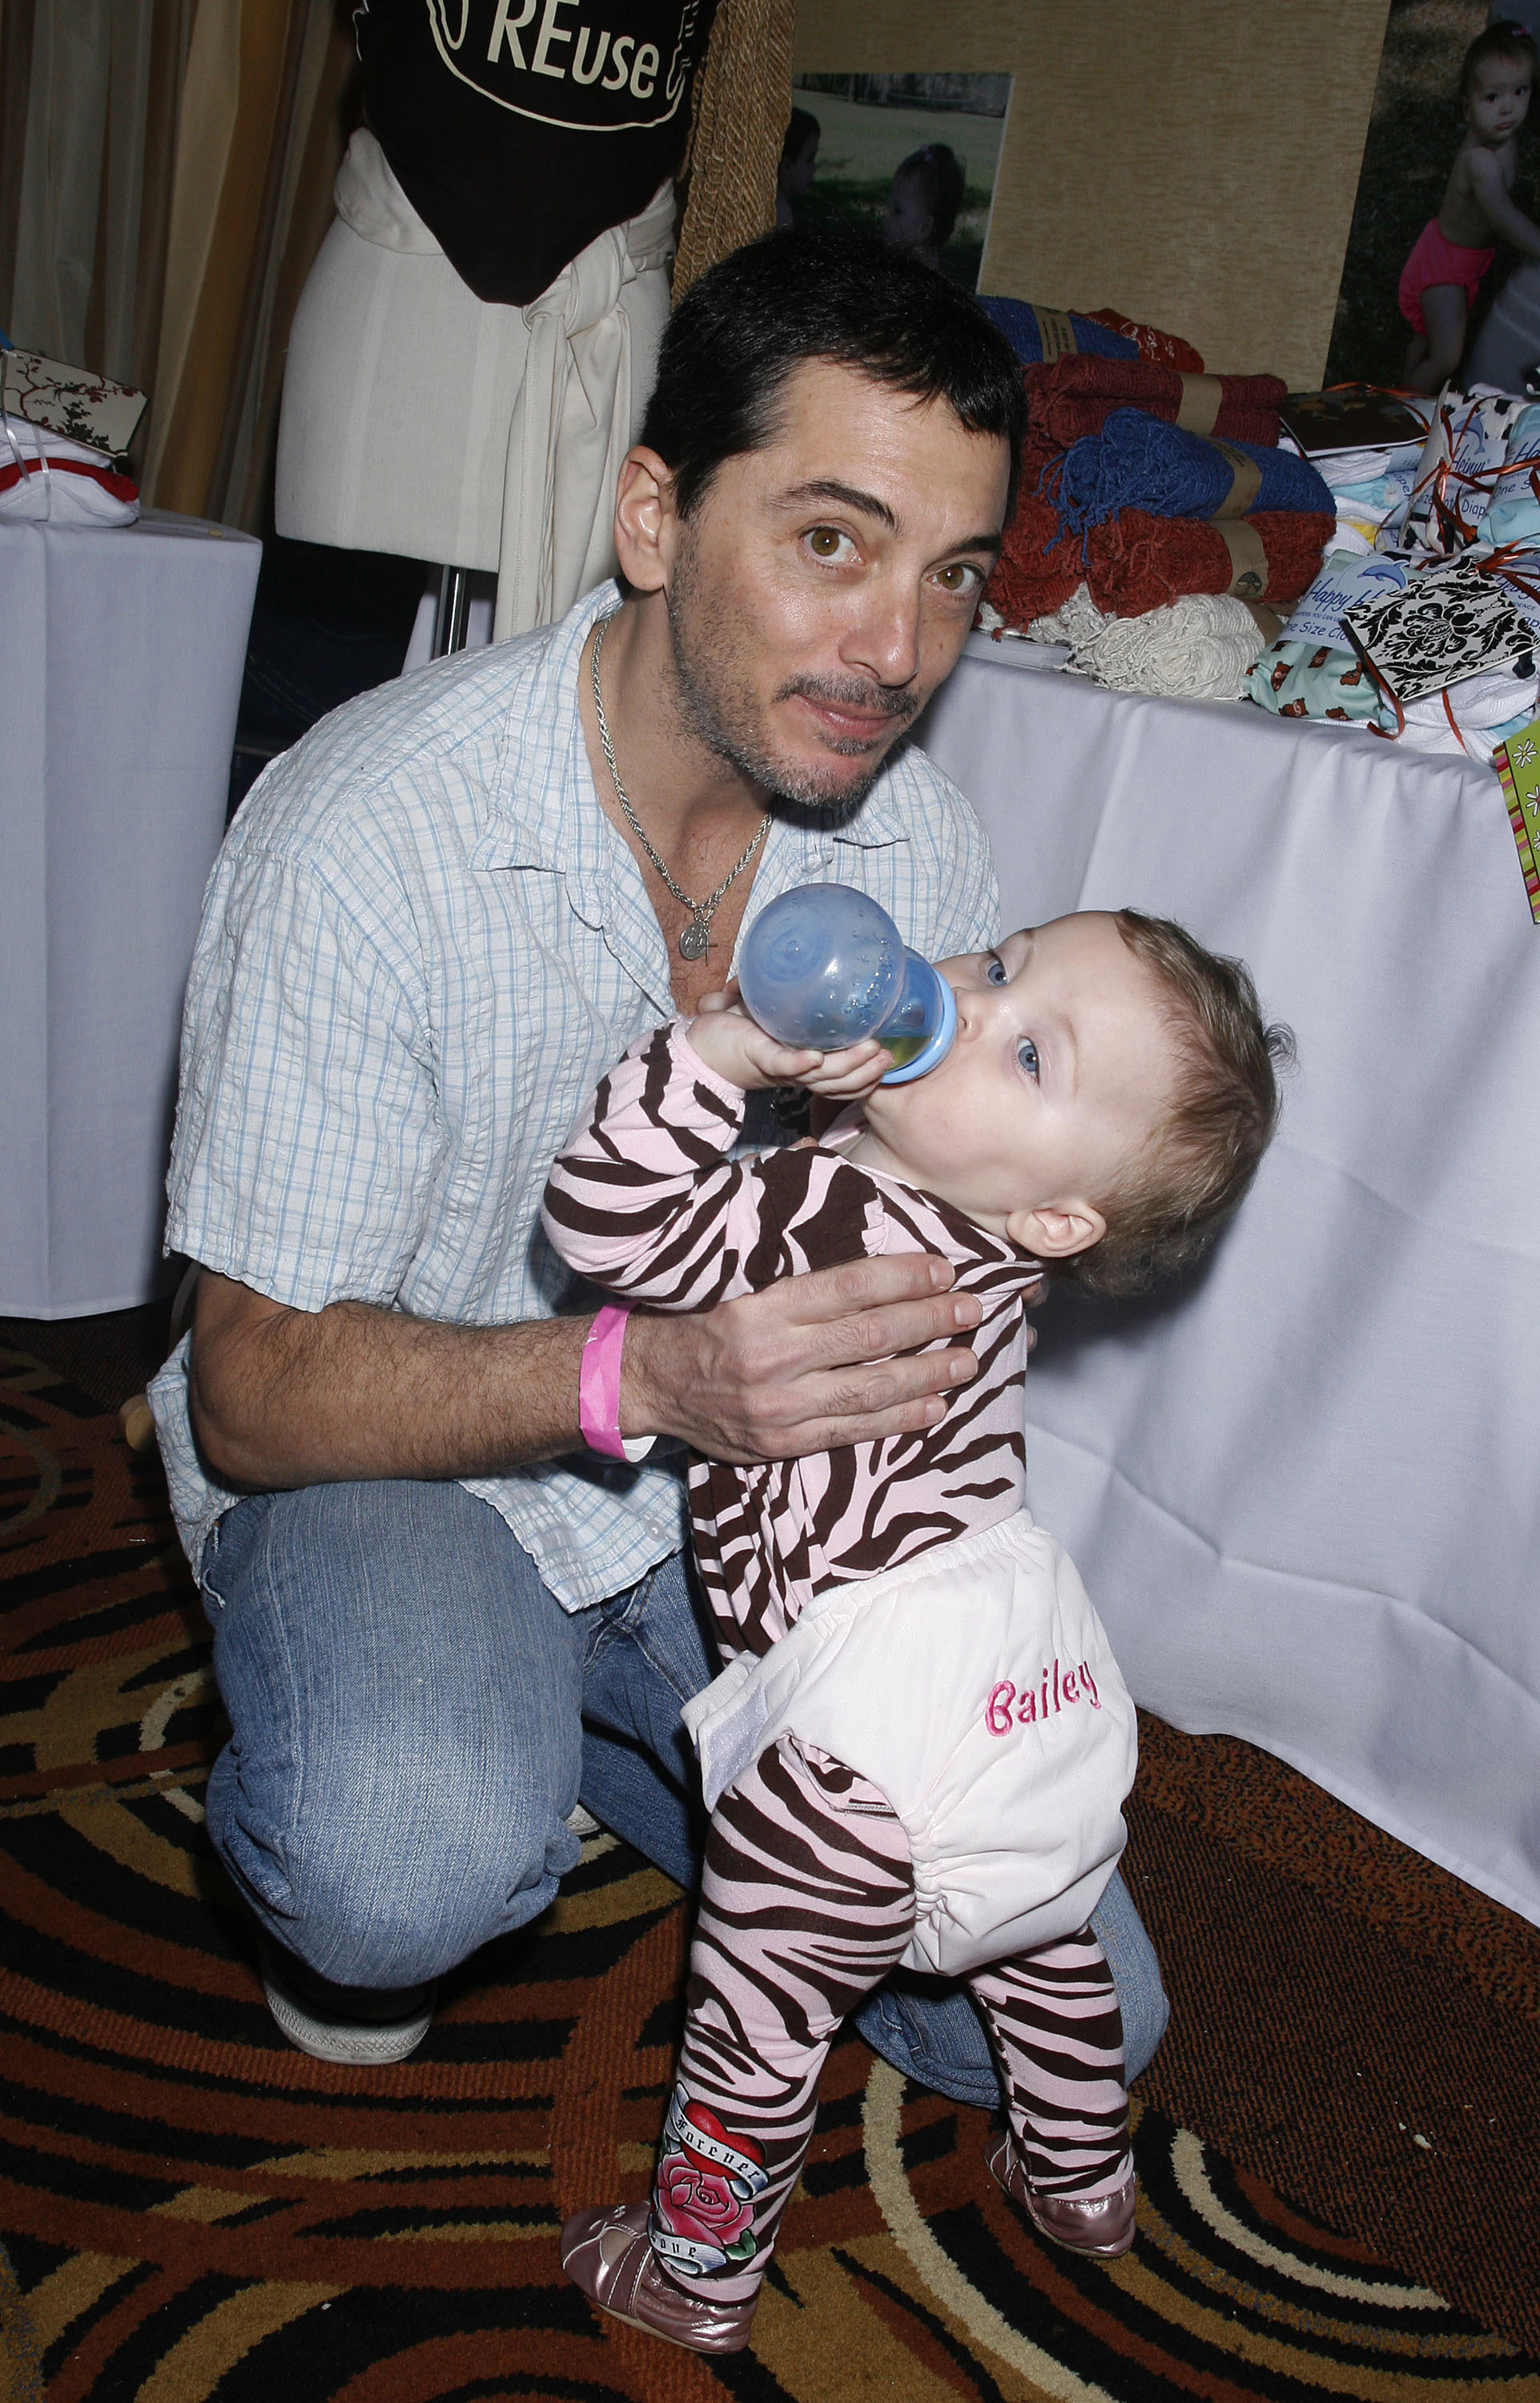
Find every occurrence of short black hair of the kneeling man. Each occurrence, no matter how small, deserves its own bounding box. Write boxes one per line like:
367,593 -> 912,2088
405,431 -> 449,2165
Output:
641,231 -> 1026,521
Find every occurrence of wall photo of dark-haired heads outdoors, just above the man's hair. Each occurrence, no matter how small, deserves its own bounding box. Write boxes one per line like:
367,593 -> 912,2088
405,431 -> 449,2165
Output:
776,74 -> 1011,291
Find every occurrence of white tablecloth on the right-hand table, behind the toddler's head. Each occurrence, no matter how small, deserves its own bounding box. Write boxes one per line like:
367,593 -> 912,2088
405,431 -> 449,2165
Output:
920,644 -> 1540,1920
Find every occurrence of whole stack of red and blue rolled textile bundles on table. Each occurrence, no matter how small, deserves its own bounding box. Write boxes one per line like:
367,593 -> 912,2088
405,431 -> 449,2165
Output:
987,353 -> 1336,630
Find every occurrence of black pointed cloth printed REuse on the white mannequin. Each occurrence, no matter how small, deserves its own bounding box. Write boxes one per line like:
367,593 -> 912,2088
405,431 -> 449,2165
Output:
353,0 -> 716,305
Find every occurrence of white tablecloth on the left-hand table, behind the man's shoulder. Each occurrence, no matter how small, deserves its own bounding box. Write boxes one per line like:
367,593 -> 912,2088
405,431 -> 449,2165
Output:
0,512 -> 262,1319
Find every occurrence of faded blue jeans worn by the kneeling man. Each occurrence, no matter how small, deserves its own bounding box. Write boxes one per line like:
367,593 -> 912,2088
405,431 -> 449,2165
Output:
202,1483 -> 1168,2105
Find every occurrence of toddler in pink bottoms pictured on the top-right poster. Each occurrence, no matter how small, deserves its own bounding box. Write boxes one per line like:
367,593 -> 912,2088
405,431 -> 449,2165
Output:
1396,24 -> 1540,392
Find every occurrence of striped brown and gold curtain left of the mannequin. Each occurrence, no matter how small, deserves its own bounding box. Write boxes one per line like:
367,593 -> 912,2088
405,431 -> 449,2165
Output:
0,0 -> 358,531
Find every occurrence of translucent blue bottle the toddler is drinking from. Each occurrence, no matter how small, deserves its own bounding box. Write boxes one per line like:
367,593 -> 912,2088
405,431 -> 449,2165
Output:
738,884 -> 956,1084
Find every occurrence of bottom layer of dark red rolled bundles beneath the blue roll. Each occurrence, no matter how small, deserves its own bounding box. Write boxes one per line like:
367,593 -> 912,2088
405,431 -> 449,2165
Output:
985,490 -> 1336,632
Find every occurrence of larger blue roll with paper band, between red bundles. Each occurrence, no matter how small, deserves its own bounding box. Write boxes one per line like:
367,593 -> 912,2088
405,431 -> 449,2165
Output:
1038,409 -> 1336,533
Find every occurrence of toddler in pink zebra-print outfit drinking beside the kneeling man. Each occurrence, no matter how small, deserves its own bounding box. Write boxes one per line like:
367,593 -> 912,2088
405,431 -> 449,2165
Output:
543,911 -> 1290,2353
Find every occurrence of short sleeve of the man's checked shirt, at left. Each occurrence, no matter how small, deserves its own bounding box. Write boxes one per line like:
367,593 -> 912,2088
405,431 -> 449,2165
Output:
166,848 -> 442,1310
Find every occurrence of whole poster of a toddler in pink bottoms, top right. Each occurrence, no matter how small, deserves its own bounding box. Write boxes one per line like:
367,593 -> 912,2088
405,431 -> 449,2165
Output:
1326,0 -> 1540,392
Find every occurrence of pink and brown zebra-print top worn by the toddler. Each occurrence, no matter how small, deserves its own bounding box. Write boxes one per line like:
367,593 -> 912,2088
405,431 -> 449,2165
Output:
543,1024 -> 1043,1660
